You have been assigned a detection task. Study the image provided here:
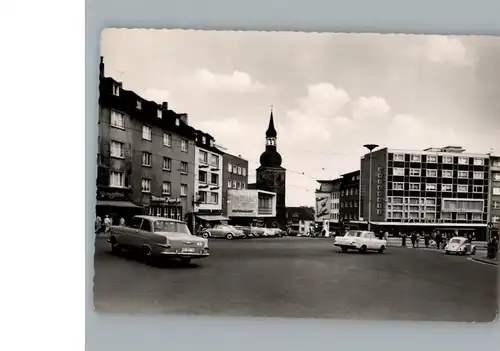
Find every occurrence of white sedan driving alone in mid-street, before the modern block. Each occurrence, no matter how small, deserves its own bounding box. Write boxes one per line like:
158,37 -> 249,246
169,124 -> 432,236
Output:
333,230 -> 387,253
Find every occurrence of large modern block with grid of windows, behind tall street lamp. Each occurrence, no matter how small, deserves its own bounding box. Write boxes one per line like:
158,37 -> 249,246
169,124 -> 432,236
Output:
360,146 -> 489,238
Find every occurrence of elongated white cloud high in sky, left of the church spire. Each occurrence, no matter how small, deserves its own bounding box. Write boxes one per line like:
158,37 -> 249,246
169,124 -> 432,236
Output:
194,69 -> 265,93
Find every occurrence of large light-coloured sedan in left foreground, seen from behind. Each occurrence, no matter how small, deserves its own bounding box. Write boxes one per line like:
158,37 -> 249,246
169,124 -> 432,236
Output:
108,216 -> 210,264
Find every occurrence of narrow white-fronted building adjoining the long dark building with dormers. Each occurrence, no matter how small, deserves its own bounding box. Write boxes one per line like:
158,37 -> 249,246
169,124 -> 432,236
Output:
194,130 -> 227,221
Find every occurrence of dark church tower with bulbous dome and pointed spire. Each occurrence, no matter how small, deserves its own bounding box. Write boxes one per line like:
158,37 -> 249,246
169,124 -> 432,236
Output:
256,108 -> 286,230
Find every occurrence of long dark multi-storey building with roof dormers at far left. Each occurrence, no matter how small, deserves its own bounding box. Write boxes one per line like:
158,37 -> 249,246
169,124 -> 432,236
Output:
97,58 -> 195,223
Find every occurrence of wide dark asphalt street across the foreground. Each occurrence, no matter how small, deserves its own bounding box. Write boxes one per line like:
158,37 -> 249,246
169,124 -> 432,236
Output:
94,237 -> 497,322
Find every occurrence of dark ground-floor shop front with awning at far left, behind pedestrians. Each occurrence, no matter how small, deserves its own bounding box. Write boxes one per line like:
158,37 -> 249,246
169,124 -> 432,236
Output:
96,186 -> 143,223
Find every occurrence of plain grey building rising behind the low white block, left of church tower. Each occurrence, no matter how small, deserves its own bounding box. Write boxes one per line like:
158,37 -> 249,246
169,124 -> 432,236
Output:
222,153 -> 248,216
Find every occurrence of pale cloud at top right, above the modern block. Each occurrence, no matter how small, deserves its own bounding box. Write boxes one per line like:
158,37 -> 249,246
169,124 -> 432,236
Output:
426,36 -> 471,66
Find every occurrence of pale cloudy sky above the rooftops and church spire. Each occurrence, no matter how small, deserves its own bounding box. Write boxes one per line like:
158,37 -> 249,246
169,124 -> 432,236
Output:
101,29 -> 500,206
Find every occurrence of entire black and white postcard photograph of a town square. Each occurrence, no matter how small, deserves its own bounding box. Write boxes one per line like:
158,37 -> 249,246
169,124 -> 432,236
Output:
93,28 -> 500,322
